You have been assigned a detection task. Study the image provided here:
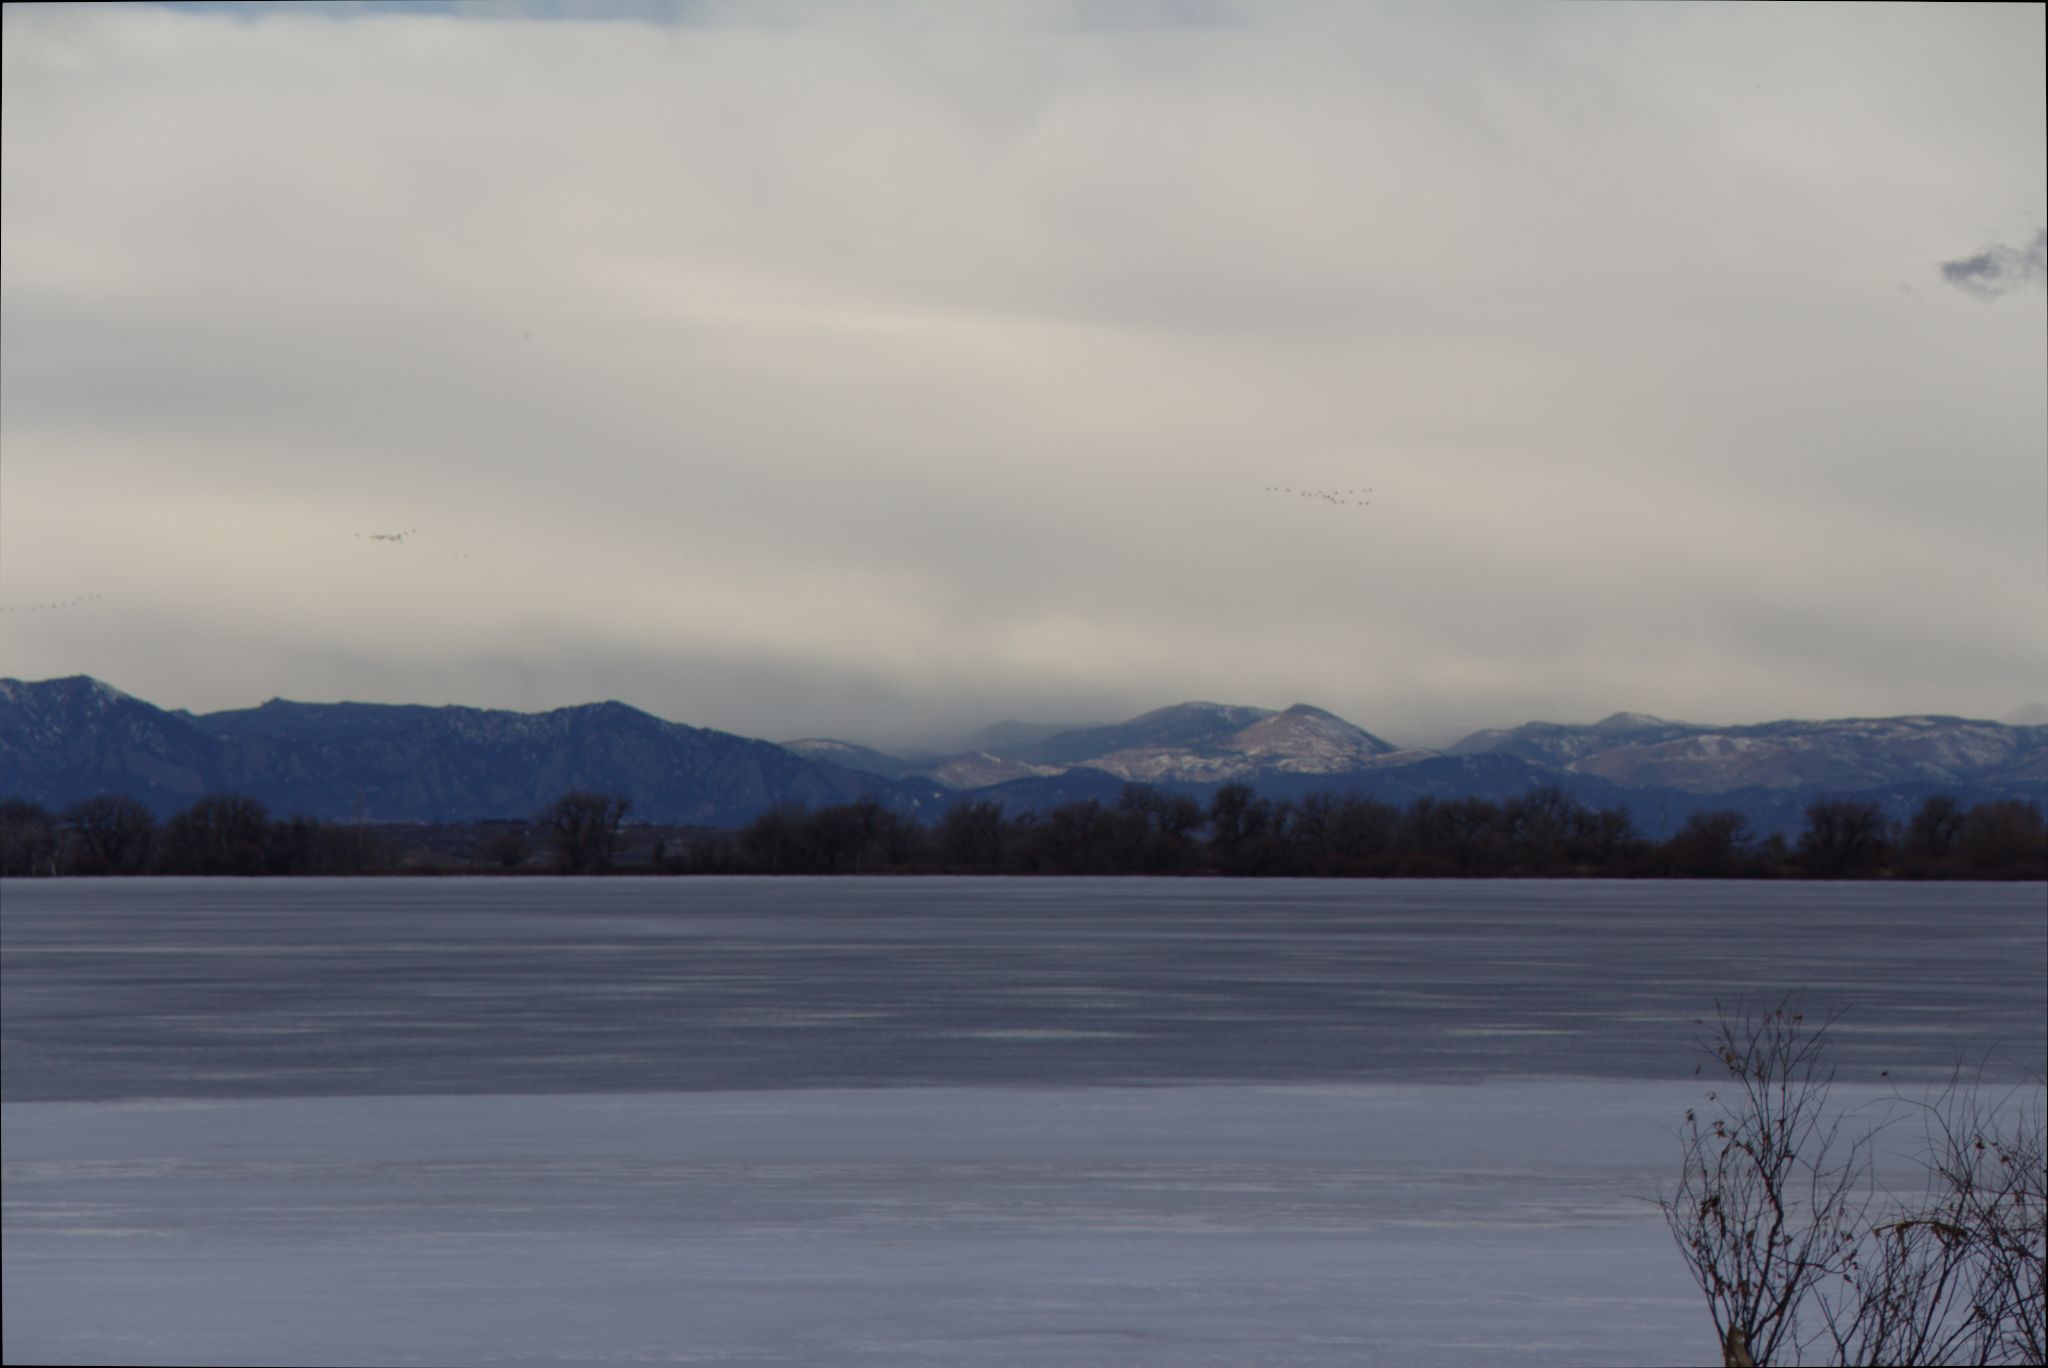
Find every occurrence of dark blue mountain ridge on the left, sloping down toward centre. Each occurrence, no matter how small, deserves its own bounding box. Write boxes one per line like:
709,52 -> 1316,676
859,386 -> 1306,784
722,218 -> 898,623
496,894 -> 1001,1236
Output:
0,678 -> 942,825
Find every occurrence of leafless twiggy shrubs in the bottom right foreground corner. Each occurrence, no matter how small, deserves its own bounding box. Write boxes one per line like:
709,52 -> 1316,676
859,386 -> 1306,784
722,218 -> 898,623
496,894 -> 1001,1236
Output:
1661,999 -> 2048,1368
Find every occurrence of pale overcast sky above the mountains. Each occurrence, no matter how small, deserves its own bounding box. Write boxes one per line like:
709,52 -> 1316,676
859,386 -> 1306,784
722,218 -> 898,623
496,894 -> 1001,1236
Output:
0,0 -> 2048,743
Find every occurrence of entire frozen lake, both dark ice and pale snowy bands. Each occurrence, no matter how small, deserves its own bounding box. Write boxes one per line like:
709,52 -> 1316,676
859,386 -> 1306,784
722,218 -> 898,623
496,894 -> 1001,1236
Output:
0,879 -> 2048,1366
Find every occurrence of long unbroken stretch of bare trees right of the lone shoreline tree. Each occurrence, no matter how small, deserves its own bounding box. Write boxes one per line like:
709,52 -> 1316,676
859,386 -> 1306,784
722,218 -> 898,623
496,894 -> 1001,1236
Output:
662,784 -> 2048,879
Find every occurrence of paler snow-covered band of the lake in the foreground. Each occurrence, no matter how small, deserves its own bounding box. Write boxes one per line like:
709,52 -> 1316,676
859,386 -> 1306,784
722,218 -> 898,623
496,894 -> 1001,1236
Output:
4,1081 -> 1712,1366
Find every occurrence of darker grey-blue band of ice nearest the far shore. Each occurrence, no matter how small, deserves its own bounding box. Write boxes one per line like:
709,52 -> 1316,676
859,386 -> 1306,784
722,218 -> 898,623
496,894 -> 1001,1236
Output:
0,879 -> 2048,1102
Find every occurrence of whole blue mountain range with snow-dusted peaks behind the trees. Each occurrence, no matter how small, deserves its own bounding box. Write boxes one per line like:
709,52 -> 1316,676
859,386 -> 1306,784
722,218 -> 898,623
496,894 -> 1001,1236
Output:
0,676 -> 2048,838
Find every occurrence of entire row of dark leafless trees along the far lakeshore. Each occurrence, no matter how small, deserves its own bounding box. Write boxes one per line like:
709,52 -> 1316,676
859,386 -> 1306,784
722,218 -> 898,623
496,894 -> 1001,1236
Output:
0,784 -> 2048,879
